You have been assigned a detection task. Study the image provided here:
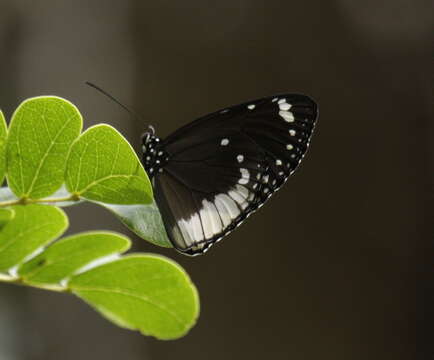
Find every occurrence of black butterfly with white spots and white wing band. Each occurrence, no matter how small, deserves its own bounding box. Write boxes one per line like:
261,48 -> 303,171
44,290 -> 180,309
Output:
143,94 -> 318,255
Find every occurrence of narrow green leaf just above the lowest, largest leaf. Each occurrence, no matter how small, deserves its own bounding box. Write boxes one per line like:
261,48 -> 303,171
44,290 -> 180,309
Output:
18,232 -> 130,284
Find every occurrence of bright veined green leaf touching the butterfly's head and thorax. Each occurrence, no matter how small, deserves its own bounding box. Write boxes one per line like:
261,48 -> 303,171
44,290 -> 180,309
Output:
66,124 -> 152,204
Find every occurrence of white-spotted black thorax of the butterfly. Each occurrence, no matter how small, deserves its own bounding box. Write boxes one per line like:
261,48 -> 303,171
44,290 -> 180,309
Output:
142,134 -> 169,178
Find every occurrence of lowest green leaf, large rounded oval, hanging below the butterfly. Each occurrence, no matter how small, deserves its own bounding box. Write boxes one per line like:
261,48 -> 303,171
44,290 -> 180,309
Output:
69,254 -> 199,339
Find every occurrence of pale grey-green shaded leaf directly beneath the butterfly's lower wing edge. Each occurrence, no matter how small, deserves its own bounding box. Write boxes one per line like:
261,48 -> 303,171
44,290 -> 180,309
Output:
99,202 -> 173,247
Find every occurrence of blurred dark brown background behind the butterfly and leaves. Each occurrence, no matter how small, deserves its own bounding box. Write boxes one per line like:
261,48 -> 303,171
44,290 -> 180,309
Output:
0,0 -> 434,360
